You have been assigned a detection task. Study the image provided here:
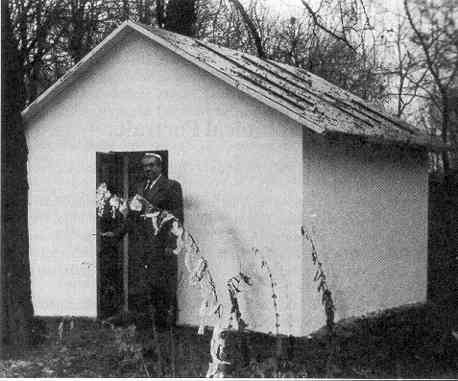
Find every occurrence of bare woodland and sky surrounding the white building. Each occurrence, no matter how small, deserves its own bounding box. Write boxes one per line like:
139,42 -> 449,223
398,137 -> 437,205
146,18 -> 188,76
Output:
0,0 -> 458,352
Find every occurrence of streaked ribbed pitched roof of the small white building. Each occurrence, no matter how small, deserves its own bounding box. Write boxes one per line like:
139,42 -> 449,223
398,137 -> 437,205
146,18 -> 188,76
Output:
24,21 -> 443,149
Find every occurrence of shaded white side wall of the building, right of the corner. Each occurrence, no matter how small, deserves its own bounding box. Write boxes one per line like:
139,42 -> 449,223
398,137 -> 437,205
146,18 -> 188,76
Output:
302,133 -> 428,332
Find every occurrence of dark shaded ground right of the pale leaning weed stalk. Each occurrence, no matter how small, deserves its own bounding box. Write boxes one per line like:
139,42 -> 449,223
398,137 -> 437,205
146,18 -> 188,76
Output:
226,305 -> 458,378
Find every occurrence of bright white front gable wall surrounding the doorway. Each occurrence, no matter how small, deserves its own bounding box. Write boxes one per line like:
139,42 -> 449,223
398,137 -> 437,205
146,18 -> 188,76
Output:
27,35 -> 303,334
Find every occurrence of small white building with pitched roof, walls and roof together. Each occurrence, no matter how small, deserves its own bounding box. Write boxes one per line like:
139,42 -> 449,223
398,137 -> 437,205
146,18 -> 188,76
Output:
23,21 -> 439,335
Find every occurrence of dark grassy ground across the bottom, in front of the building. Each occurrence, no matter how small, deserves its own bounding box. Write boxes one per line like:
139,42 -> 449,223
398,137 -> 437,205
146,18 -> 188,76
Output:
0,304 -> 458,378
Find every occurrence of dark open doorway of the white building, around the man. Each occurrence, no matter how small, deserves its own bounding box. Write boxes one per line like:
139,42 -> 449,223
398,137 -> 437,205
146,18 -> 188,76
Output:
96,150 -> 168,319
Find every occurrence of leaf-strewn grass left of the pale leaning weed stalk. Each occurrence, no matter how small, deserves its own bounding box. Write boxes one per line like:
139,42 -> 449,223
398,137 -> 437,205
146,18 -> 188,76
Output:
0,321 -> 210,377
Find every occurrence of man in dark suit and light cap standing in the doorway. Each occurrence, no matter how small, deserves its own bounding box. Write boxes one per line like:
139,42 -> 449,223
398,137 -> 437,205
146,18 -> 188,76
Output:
104,153 -> 183,327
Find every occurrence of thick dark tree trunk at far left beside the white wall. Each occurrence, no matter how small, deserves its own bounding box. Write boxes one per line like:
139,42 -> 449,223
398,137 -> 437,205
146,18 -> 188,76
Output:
0,2 -> 33,346
